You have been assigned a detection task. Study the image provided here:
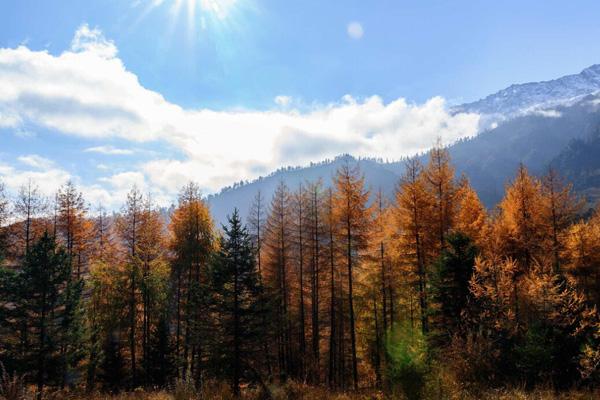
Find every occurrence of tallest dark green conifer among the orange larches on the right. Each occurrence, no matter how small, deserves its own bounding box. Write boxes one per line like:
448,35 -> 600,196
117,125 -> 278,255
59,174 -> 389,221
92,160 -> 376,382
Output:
429,232 -> 478,349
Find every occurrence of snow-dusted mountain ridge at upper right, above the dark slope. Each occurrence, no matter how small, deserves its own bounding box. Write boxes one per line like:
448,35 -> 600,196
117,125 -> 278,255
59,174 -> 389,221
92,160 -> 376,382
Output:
453,64 -> 600,119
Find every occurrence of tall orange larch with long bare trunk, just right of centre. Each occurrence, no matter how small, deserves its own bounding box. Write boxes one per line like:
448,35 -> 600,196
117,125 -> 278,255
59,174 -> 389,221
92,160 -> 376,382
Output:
333,164 -> 371,389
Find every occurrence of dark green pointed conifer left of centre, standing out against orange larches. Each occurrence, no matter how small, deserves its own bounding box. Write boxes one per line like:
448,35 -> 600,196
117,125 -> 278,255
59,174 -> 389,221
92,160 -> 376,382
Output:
211,209 -> 266,396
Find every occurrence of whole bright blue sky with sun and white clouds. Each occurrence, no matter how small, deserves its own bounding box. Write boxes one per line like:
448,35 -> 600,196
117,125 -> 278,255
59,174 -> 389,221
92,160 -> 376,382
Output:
0,0 -> 600,208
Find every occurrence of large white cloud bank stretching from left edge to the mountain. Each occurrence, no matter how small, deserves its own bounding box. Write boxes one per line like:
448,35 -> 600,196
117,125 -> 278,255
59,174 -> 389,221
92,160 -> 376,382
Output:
0,25 -> 479,206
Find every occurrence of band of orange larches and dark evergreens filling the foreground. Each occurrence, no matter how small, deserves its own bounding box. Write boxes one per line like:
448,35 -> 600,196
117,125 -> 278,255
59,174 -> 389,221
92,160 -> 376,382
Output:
0,146 -> 600,400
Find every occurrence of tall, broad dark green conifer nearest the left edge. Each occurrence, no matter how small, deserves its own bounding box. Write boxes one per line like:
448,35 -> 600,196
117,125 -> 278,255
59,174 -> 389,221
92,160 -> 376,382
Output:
16,232 -> 73,397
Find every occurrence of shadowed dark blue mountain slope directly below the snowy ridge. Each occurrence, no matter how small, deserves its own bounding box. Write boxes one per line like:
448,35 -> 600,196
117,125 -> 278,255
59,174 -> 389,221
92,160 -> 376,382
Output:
450,96 -> 600,206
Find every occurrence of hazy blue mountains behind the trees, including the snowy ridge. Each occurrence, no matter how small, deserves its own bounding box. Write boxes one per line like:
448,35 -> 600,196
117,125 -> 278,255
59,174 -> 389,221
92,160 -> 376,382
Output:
209,65 -> 600,221
